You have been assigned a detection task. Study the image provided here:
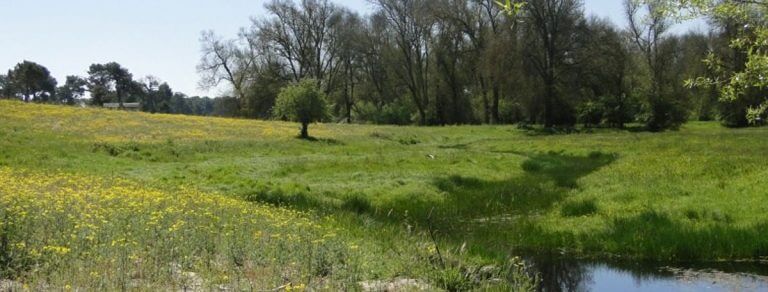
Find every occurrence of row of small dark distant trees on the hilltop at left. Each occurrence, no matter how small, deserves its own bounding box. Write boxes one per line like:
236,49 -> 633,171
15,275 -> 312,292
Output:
0,60 -> 238,116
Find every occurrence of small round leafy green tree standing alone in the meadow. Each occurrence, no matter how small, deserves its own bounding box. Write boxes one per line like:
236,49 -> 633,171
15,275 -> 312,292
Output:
273,79 -> 327,139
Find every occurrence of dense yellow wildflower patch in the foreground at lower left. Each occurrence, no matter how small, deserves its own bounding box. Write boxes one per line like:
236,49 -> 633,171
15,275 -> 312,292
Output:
0,167 -> 343,288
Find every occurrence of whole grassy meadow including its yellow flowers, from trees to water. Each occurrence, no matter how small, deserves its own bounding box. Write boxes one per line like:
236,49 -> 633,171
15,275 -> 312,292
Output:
0,101 -> 768,290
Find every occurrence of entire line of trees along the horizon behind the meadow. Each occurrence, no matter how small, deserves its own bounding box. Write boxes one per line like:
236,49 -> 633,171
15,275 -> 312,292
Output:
0,0 -> 768,131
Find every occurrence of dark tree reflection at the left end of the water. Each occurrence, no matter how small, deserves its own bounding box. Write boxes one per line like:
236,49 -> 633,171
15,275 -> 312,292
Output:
526,258 -> 592,292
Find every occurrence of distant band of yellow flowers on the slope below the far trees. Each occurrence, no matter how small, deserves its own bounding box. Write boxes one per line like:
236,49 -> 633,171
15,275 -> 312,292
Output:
0,100 -> 330,142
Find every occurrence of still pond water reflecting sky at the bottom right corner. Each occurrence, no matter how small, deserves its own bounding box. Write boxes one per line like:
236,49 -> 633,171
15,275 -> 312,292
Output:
528,258 -> 768,292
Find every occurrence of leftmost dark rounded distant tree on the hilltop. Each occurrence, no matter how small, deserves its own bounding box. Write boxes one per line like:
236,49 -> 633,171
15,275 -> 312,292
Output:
8,61 -> 56,102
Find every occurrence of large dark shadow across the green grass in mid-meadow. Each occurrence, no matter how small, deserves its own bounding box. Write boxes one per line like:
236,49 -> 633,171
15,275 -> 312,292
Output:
372,152 -> 616,231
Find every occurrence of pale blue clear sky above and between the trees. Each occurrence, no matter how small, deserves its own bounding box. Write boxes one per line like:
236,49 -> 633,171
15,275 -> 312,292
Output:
0,0 -> 706,96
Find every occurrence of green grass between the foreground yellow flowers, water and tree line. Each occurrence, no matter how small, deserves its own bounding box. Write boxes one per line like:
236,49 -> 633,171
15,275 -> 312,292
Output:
0,102 -> 768,288
